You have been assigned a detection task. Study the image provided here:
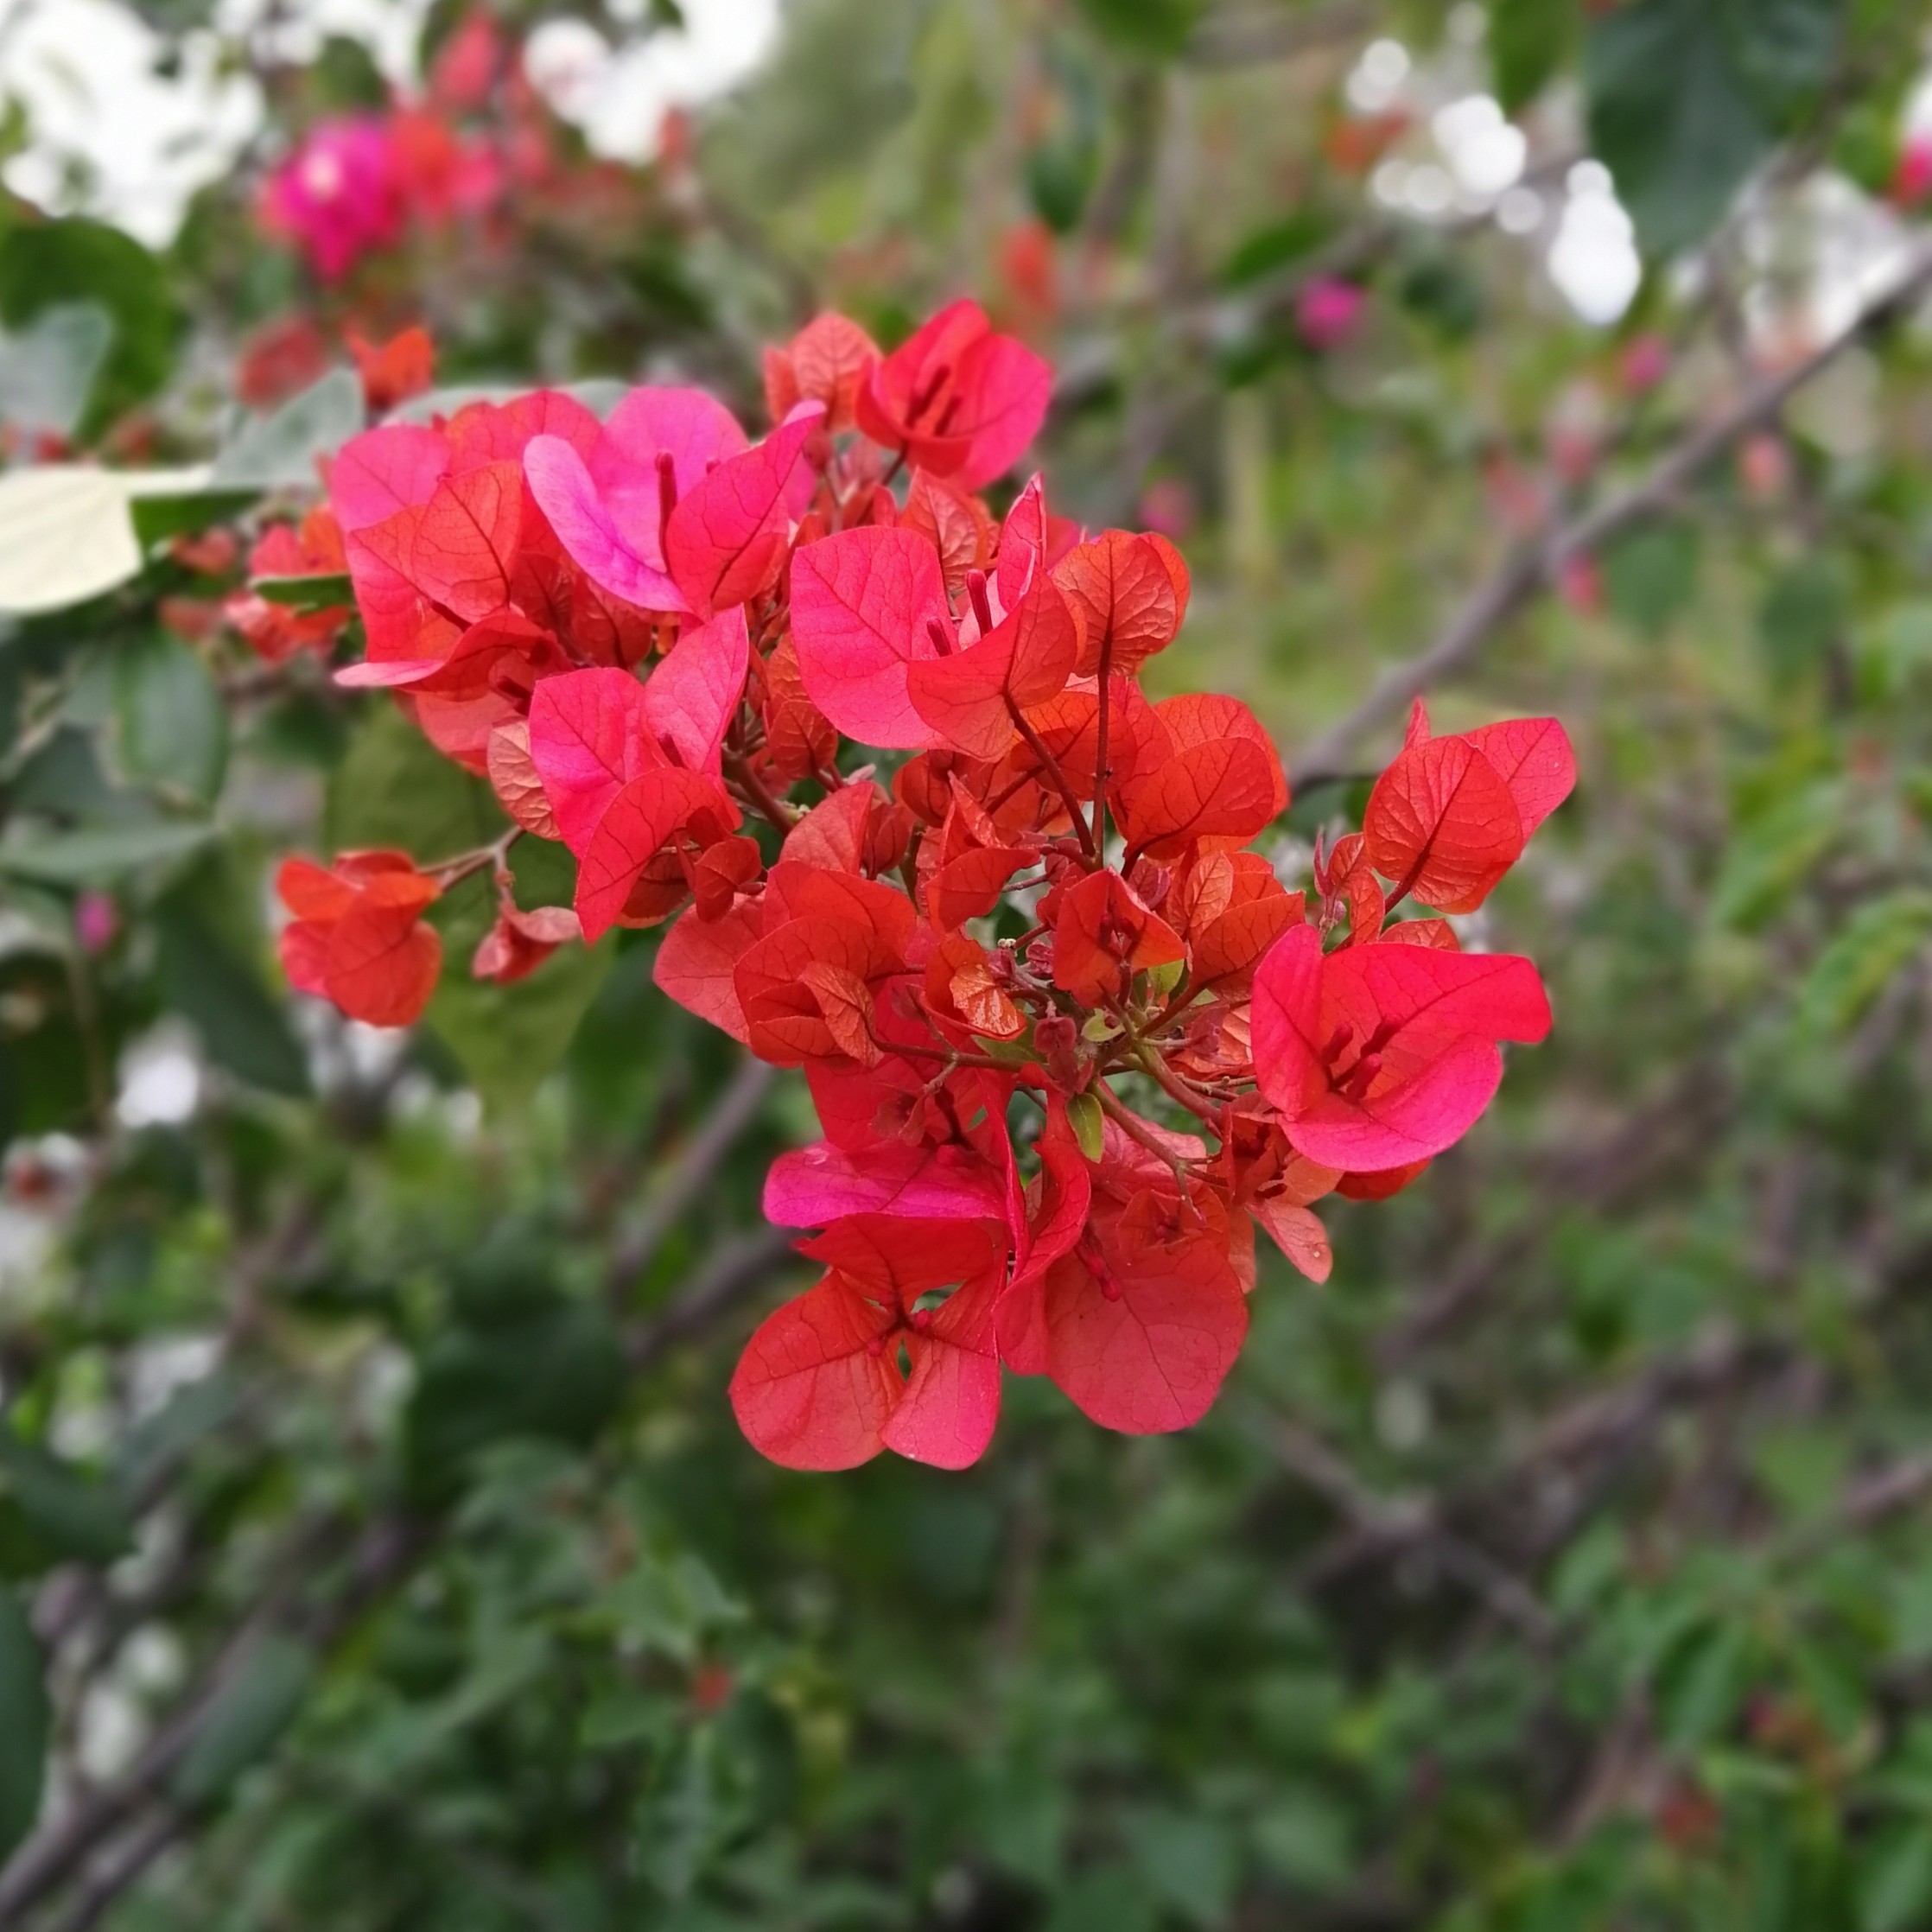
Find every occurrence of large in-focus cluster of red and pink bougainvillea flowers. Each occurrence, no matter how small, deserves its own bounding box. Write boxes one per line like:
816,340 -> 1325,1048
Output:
282,303 -> 1574,1468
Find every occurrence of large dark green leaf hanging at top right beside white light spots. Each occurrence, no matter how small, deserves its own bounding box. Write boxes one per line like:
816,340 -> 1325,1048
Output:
1582,0 -> 1837,255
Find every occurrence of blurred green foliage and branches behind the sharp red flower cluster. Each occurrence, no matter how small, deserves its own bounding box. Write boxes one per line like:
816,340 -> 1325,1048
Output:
18,0 -> 1932,1932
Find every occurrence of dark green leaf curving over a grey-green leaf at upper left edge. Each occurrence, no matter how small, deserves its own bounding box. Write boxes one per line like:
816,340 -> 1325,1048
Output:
0,216 -> 186,433
